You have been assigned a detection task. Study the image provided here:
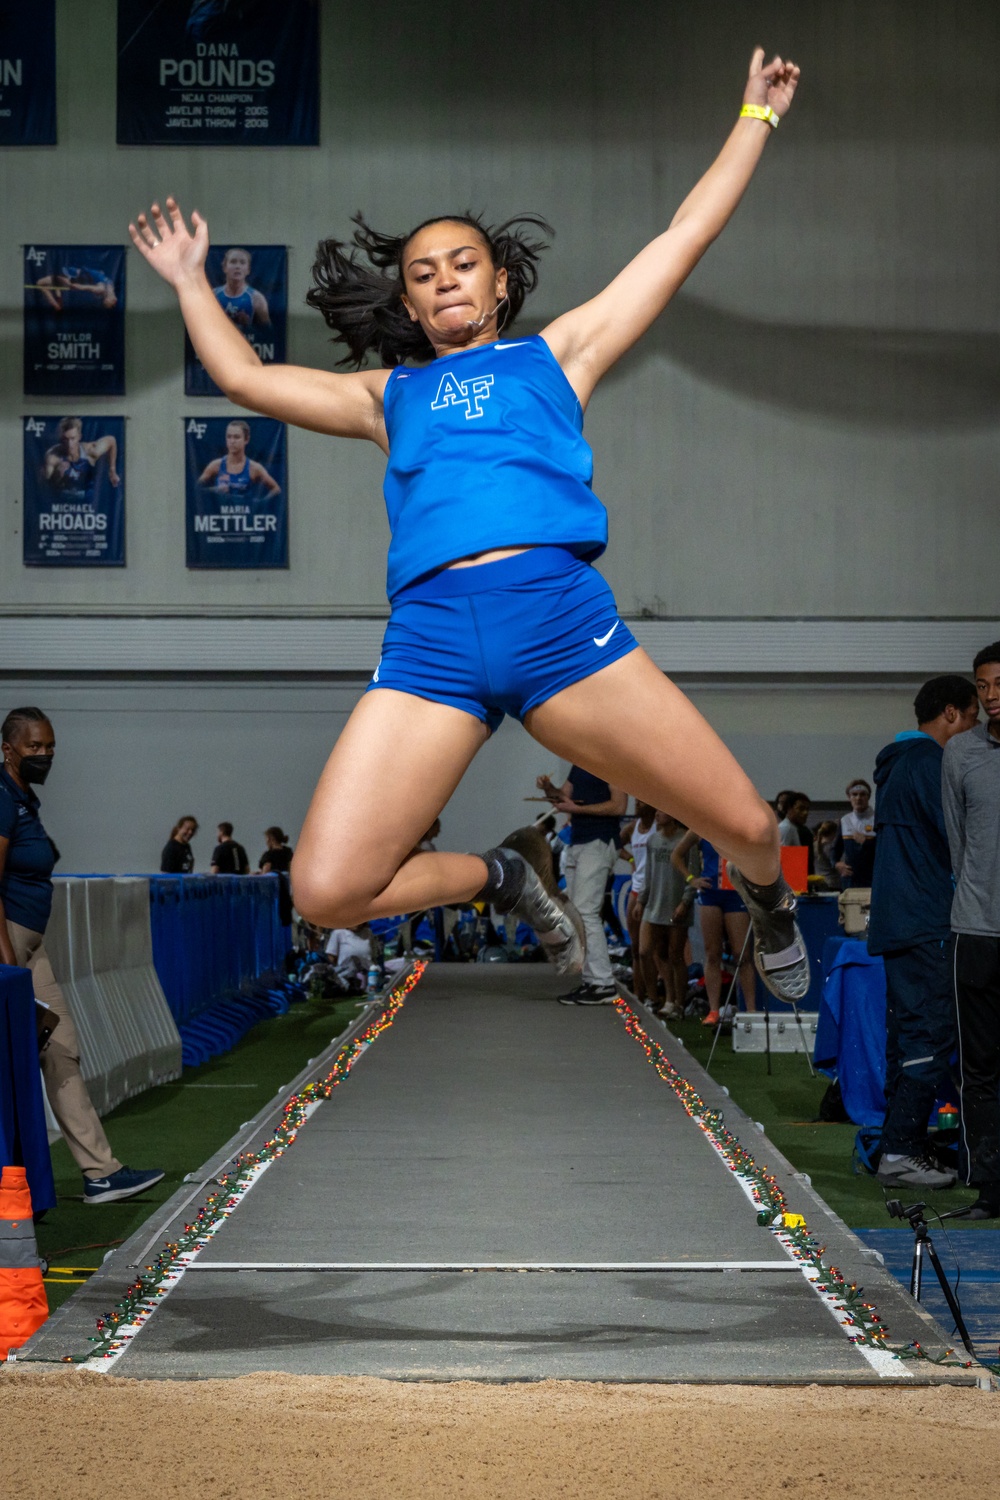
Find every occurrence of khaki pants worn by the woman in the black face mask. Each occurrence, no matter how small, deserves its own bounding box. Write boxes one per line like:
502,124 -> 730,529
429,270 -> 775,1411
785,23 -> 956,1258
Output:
7,921 -> 121,1178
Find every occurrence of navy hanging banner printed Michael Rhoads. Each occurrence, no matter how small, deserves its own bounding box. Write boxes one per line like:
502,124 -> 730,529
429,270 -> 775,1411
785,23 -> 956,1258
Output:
24,417 -> 124,567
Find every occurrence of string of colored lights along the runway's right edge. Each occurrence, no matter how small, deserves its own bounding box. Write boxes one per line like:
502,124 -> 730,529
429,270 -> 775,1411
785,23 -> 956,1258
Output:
615,998 -> 972,1370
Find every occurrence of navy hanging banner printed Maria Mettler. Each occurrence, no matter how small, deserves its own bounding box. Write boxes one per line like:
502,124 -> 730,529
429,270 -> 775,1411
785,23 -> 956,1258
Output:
184,417 -> 288,569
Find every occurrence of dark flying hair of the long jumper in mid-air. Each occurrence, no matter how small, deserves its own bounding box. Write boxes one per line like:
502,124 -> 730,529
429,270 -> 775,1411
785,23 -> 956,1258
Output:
306,213 -> 553,369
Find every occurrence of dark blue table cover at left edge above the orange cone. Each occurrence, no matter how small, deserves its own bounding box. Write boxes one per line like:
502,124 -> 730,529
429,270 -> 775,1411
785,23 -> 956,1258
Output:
0,963 -> 55,1214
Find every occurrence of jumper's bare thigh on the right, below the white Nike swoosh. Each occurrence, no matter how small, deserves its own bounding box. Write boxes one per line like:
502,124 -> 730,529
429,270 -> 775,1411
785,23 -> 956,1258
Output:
525,648 -> 762,845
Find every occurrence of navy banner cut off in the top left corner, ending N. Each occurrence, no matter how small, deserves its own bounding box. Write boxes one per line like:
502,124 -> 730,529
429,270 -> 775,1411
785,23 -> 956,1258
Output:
0,0 -> 55,146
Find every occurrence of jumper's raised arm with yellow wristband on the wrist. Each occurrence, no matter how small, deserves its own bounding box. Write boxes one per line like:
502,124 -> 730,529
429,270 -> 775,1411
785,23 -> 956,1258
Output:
543,47 -> 799,405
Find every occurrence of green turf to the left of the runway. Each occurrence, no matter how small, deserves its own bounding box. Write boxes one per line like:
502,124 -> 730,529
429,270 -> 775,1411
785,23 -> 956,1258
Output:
37,1001 -> 364,1310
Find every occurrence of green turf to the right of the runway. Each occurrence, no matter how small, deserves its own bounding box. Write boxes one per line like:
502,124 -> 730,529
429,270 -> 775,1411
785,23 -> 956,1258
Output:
669,1022 -> 996,1229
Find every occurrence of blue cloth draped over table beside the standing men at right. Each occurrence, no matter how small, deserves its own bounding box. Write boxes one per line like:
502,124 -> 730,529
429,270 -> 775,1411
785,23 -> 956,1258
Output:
813,938 -> 886,1125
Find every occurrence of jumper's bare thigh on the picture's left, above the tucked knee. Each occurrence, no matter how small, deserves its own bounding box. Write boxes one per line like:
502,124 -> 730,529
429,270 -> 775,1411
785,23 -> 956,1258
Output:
294,689 -> 489,890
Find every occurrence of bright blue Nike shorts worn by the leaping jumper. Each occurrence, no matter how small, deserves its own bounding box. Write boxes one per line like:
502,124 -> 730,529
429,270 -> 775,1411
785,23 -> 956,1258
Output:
367,548 -> 637,732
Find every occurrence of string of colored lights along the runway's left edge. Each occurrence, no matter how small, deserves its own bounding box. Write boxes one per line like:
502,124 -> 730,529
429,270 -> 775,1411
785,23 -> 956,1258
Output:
63,960 -> 427,1365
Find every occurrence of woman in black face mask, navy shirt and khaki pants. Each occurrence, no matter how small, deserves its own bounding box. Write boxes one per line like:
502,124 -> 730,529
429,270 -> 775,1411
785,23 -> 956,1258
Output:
0,708 -> 163,1203
